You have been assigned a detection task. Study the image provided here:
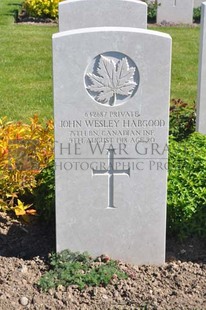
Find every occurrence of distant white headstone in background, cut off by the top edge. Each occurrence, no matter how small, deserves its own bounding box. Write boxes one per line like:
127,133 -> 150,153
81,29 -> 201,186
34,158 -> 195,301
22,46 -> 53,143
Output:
157,0 -> 194,24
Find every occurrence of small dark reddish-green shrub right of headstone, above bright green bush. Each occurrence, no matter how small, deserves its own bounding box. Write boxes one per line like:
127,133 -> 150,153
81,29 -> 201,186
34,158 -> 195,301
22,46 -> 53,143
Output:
169,99 -> 196,141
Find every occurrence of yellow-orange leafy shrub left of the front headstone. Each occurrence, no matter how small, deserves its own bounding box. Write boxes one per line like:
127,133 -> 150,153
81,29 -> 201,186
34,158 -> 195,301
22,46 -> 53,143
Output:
0,116 -> 54,219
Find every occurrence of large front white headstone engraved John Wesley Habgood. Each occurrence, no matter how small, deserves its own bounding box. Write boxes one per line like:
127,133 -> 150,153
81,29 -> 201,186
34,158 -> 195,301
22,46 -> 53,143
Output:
53,27 -> 171,264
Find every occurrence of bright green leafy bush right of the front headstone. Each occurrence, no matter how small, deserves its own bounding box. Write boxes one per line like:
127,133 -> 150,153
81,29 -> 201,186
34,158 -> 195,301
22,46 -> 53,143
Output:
167,133 -> 206,238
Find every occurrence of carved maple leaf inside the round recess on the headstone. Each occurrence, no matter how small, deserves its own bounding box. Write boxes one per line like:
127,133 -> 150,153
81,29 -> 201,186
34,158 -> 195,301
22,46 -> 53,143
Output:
87,55 -> 137,106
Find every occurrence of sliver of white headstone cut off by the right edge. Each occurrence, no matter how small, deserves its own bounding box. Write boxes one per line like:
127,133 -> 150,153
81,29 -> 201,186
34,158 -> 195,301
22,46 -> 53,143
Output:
196,2 -> 206,134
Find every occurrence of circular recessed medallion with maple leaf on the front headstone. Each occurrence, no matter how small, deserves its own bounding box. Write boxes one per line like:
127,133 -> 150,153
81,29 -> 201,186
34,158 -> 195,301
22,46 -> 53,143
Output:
85,53 -> 139,106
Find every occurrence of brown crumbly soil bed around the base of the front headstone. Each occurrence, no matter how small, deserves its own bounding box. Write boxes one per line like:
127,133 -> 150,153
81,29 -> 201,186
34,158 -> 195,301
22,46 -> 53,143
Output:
0,213 -> 206,310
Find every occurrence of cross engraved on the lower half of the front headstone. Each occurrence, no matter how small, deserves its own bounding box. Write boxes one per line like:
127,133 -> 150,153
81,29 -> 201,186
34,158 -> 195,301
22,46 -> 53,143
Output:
92,149 -> 130,209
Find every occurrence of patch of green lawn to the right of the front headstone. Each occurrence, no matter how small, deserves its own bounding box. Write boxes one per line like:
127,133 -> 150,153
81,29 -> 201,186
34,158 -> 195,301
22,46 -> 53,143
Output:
153,26 -> 200,104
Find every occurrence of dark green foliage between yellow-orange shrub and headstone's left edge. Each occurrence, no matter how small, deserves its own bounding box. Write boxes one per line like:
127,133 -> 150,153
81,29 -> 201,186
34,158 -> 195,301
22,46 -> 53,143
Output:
33,161 -> 55,222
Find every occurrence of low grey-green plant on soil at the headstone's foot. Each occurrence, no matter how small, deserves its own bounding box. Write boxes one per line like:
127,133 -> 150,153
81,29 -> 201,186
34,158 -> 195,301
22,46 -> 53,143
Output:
38,250 -> 127,291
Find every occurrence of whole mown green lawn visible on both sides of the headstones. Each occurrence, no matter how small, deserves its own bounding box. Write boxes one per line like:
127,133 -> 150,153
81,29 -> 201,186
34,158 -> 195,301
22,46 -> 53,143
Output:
0,0 -> 199,121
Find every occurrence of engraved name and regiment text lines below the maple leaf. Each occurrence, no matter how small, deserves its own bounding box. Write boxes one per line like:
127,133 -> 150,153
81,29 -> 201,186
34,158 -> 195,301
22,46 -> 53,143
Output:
59,115 -> 165,145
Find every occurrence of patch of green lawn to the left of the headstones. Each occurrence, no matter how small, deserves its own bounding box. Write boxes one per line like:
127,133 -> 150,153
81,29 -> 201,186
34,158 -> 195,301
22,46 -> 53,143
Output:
0,0 -> 58,121
